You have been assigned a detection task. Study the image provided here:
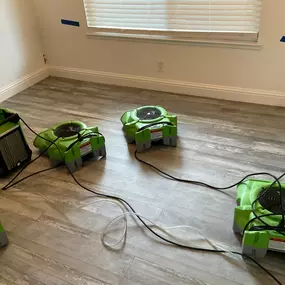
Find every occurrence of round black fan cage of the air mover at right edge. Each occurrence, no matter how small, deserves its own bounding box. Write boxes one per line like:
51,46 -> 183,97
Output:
259,187 -> 285,215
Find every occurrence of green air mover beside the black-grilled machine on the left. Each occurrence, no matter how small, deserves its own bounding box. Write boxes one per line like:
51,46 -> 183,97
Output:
34,121 -> 106,172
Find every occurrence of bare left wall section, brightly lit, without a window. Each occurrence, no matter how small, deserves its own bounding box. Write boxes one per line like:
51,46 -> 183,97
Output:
0,0 -> 44,89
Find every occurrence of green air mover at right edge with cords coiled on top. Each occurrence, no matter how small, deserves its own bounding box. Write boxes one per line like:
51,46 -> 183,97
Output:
233,179 -> 285,258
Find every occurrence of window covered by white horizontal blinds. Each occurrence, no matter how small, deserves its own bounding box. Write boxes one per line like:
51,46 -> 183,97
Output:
84,0 -> 262,42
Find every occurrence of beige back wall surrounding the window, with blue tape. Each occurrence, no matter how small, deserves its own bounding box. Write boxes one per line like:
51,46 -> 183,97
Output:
36,0 -> 285,92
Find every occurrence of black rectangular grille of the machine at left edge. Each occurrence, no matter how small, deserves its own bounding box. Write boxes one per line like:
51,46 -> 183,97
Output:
0,126 -> 30,172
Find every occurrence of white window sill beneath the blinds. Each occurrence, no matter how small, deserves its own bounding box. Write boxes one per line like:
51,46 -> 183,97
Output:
86,32 -> 262,50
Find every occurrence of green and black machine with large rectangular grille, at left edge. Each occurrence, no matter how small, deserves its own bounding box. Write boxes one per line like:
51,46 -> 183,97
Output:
0,109 -> 32,176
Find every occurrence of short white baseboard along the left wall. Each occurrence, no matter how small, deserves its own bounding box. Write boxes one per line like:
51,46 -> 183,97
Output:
0,68 -> 49,102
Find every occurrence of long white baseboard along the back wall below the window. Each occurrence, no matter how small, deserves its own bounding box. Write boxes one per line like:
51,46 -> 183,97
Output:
50,66 -> 285,106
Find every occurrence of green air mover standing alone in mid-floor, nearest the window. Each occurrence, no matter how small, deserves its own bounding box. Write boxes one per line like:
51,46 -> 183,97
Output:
121,106 -> 177,152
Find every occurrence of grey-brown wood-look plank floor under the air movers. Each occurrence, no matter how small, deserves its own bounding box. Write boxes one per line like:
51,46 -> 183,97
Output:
0,77 -> 285,285
